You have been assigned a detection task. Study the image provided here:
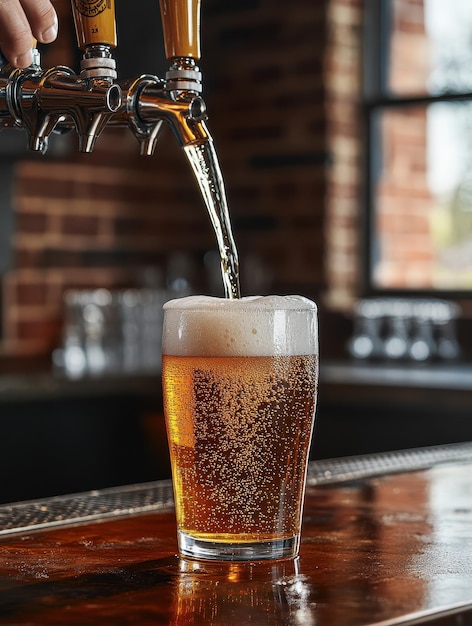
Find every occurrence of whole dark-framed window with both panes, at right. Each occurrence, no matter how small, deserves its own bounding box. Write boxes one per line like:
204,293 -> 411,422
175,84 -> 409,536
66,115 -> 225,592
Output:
364,0 -> 472,297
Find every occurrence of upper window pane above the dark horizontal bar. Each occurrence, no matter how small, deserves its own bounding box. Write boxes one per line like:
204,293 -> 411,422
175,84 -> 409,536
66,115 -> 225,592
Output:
385,0 -> 472,96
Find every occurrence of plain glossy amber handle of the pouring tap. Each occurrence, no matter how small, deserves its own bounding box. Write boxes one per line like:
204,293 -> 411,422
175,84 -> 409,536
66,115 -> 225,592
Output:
159,0 -> 200,61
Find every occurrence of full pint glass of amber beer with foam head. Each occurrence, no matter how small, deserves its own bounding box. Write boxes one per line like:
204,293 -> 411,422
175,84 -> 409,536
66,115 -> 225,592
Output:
162,296 -> 318,560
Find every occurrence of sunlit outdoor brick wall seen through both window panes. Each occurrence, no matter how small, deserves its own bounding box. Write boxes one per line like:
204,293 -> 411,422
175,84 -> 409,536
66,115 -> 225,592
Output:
374,0 -> 435,289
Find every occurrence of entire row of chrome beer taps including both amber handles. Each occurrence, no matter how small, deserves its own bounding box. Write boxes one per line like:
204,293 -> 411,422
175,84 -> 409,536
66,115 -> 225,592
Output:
0,0 -> 211,155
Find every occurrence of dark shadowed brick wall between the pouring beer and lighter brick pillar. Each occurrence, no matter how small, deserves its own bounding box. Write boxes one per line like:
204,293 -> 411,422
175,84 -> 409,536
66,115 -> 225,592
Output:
202,0 -> 327,295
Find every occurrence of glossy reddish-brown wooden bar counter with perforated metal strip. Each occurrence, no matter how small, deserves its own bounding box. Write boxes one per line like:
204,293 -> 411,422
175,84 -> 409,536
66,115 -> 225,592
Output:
0,443 -> 472,626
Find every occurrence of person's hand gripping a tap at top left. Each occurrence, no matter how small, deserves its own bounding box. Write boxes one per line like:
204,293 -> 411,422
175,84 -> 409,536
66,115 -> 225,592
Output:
0,0 -> 57,67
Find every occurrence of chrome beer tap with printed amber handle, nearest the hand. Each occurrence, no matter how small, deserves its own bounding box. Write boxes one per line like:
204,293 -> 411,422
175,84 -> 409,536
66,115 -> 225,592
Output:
0,0 -> 121,153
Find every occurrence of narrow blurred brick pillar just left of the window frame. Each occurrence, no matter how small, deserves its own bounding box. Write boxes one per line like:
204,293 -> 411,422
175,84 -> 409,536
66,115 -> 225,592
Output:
324,0 -> 363,312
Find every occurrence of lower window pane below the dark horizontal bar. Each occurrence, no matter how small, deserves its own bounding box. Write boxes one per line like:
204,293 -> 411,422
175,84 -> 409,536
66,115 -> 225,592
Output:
371,101 -> 472,291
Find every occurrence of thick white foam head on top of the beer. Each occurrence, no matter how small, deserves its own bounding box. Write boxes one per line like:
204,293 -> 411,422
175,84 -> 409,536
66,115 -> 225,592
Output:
163,296 -> 318,356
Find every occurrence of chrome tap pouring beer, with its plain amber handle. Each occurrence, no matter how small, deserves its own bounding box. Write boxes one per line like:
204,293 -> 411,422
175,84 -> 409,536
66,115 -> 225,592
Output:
111,0 -> 209,155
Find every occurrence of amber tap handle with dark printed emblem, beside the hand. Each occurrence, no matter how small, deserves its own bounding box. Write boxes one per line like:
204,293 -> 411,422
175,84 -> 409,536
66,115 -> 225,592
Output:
71,0 -> 116,50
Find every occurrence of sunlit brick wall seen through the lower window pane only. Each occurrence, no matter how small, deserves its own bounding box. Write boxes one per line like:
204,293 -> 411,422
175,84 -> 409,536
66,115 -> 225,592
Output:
374,108 -> 435,289
